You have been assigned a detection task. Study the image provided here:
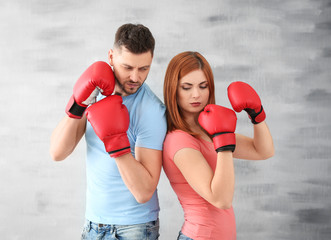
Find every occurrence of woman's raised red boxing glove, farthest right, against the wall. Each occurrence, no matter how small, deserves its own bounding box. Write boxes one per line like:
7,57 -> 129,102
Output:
228,82 -> 266,124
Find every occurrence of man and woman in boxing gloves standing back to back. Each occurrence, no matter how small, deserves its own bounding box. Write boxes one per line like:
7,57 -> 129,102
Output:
50,24 -> 274,240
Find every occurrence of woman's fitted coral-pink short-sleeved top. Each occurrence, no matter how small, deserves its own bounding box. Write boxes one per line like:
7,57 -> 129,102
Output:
163,130 -> 236,240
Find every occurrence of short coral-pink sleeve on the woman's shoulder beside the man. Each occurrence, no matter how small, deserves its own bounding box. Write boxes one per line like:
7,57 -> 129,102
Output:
164,130 -> 201,162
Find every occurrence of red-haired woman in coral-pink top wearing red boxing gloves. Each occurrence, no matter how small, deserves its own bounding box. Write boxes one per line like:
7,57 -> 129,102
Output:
163,52 -> 274,240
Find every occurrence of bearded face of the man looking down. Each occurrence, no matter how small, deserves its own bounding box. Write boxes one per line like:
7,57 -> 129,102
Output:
109,47 -> 153,96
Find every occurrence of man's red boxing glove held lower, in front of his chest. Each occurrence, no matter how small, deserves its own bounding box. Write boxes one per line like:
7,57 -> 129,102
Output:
86,95 -> 131,158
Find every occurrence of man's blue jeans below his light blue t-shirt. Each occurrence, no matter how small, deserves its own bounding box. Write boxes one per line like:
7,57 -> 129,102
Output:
82,220 -> 159,240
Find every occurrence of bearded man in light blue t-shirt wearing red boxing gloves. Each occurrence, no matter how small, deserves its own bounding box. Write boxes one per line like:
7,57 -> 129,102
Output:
50,24 -> 166,240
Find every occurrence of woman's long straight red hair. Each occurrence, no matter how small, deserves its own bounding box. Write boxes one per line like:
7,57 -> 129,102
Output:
163,51 -> 215,136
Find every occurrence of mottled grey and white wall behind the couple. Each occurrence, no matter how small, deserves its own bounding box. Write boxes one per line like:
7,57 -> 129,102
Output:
0,0 -> 331,240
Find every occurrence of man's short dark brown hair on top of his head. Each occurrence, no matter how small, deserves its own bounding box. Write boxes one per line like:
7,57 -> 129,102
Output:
114,23 -> 155,56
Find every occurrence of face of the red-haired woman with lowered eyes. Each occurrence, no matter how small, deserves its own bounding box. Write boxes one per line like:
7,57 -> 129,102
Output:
177,69 -> 209,116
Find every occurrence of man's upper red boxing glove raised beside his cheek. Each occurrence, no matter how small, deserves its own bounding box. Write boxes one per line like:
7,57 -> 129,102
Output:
66,61 -> 115,119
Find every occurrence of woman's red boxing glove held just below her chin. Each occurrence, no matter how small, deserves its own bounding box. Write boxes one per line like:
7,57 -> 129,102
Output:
198,104 -> 237,152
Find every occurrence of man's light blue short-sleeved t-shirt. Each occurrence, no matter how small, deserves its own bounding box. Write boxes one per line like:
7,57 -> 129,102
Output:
85,83 -> 167,225
